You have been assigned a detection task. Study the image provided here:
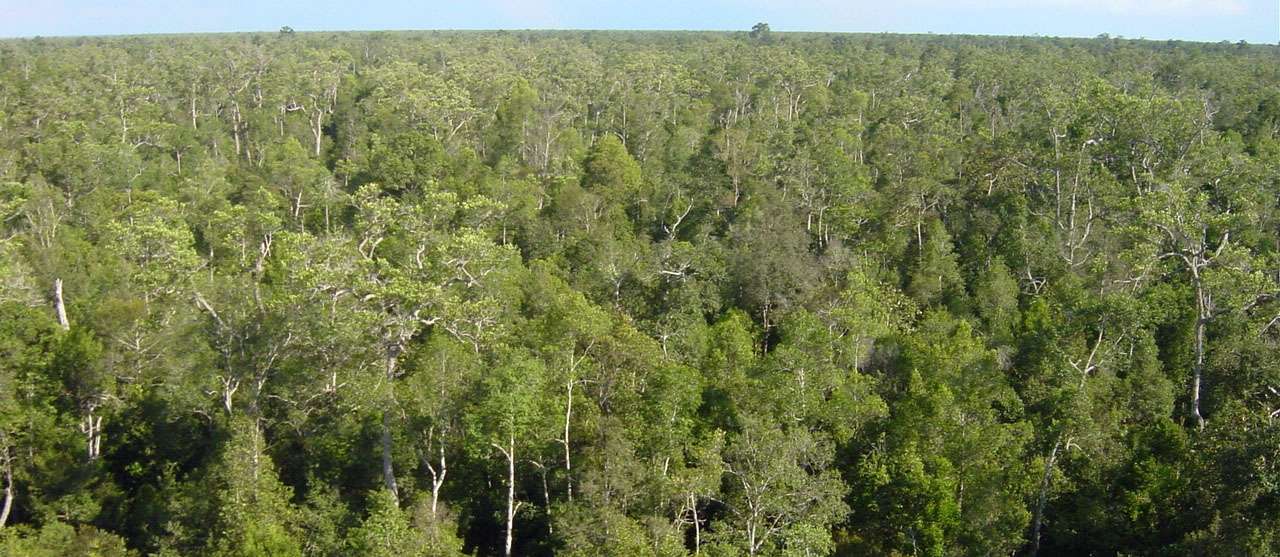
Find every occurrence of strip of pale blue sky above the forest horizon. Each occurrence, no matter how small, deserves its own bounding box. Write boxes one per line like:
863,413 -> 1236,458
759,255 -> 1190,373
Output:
0,0 -> 1280,44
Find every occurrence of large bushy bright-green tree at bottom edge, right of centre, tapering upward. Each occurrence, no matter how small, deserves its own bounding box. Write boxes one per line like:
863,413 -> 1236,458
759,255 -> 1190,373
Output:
850,310 -> 1034,554
